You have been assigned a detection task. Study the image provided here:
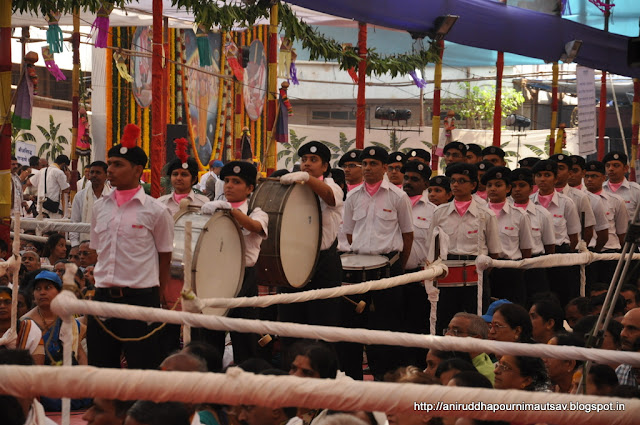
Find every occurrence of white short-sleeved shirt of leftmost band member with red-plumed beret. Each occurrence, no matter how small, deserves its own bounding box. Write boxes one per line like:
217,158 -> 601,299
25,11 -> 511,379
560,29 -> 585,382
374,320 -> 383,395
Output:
90,187 -> 173,289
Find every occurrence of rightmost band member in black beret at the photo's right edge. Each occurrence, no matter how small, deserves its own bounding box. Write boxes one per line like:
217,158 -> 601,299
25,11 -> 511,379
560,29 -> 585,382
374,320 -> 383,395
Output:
602,151 -> 640,220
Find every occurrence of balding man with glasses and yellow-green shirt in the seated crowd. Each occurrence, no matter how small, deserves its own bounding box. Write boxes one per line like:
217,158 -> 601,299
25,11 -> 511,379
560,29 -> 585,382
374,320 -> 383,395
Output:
443,313 -> 496,385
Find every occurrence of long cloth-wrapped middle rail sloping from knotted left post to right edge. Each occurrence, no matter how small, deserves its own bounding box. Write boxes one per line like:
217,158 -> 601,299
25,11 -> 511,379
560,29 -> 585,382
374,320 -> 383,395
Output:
51,290 -> 640,365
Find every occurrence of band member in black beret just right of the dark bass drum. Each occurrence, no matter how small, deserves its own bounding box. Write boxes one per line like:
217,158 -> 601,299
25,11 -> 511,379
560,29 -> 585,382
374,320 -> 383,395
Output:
342,146 -> 413,379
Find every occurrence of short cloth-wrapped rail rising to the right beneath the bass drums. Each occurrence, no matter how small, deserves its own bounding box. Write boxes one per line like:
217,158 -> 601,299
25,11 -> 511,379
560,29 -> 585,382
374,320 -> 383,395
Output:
182,260 -> 448,313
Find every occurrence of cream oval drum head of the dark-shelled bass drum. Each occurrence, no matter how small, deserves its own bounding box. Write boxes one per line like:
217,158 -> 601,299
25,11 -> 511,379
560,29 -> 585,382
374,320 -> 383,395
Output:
280,184 -> 322,288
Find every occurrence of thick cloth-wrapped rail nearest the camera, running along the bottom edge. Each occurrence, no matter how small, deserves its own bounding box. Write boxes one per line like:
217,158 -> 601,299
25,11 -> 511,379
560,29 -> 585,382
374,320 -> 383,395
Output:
0,365 -> 640,425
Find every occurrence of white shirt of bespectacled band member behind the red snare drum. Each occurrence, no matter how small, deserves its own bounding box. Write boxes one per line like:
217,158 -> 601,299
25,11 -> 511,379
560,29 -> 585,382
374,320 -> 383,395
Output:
429,198 -> 502,255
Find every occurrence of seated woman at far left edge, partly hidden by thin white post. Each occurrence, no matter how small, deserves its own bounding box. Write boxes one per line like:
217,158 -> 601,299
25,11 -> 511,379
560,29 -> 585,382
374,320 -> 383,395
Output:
0,286 -> 44,365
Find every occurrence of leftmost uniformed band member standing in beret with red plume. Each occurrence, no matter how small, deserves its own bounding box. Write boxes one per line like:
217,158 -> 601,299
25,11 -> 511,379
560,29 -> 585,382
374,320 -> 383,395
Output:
87,124 -> 173,369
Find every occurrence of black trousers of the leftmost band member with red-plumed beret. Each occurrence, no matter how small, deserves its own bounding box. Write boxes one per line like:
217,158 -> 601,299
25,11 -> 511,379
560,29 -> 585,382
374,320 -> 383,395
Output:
87,287 -> 168,369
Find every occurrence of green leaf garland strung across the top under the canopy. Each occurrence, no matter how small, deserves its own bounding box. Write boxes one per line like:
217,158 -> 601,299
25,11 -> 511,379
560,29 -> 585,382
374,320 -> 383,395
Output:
12,0 -> 439,77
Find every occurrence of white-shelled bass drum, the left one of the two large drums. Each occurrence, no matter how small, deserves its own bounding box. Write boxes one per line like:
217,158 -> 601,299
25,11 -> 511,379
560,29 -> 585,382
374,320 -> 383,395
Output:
170,211 -> 244,316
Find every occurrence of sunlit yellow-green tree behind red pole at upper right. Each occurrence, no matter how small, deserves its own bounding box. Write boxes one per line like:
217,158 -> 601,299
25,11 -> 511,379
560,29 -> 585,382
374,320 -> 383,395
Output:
457,82 -> 524,130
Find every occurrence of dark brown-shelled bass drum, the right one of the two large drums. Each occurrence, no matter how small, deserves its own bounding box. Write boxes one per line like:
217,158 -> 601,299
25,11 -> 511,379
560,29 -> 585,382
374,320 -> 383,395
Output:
249,179 -> 322,288
